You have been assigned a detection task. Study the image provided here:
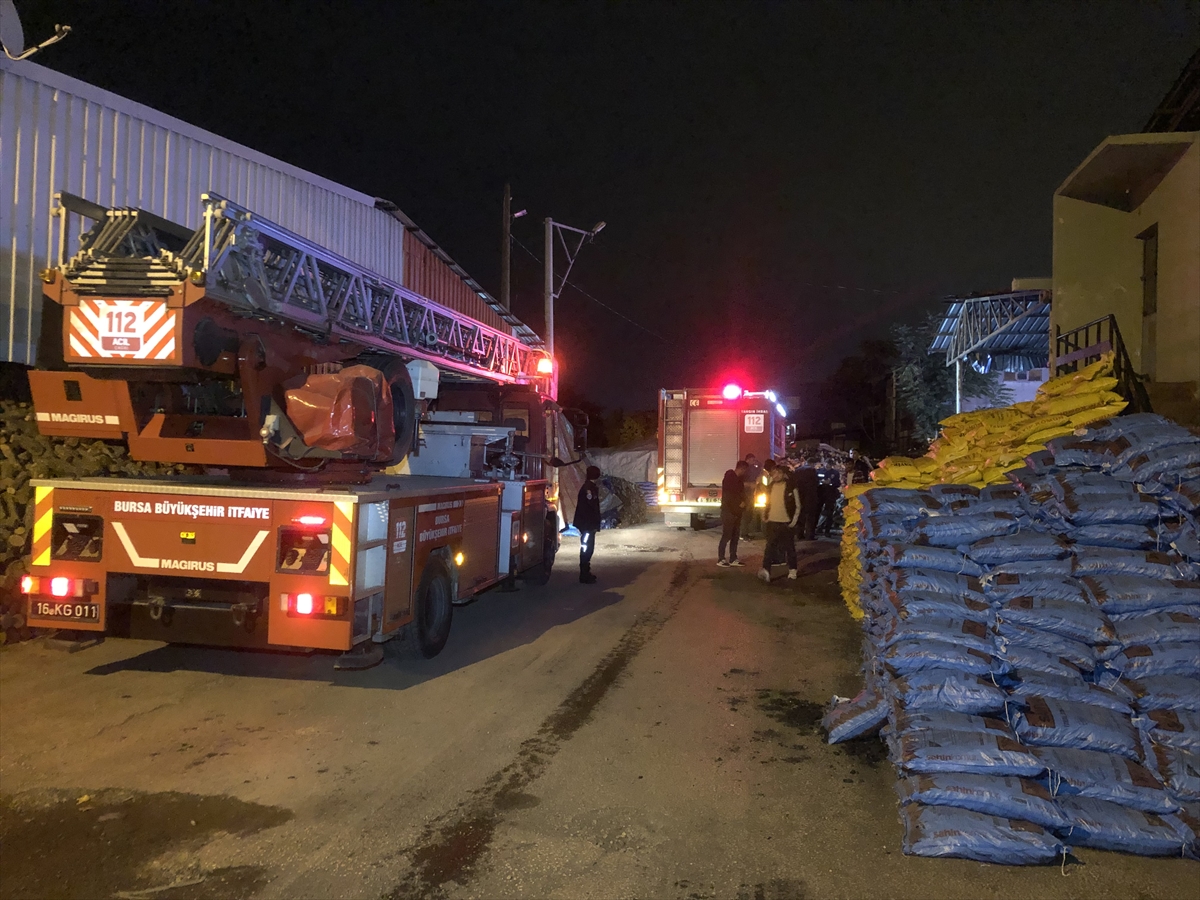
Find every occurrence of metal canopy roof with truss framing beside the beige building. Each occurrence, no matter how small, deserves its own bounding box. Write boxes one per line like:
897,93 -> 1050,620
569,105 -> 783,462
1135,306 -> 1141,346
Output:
929,290 -> 1050,372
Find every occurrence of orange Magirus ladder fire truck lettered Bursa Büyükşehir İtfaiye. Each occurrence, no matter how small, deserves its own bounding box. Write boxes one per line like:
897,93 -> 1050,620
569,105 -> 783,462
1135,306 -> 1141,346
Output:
22,194 -> 584,667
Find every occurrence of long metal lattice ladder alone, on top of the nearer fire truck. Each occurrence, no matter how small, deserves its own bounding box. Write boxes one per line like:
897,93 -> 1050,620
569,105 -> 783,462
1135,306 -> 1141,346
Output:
54,194 -> 547,383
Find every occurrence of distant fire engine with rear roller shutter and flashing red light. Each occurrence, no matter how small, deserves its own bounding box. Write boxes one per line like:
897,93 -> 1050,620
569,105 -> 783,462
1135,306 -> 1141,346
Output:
659,384 -> 787,528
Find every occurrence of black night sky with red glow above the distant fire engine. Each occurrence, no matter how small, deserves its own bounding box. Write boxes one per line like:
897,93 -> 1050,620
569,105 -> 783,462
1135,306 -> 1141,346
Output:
17,0 -> 1200,408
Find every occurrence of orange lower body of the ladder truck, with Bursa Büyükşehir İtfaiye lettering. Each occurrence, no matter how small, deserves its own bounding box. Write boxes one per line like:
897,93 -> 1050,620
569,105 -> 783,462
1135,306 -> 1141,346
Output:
29,475 -> 511,650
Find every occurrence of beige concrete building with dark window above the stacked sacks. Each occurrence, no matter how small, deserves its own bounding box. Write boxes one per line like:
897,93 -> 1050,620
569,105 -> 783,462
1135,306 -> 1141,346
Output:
1050,131 -> 1200,422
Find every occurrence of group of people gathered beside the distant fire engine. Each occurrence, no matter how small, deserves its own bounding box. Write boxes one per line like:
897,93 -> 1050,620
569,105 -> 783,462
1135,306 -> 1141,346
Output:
716,454 -> 841,582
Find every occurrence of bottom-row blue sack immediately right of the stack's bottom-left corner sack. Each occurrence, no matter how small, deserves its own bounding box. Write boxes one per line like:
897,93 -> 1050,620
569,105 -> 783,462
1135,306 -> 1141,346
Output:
1038,746 -> 1178,815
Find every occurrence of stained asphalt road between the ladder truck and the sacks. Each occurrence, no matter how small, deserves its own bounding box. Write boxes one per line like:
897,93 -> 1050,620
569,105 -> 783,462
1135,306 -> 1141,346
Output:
0,526 -> 1200,900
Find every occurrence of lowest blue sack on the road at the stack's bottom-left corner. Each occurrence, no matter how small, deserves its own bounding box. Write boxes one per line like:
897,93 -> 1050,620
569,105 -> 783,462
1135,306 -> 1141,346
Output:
900,803 -> 1067,865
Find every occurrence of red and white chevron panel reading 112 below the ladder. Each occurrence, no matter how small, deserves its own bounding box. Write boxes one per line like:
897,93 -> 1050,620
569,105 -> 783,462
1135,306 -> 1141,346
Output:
67,298 -> 179,361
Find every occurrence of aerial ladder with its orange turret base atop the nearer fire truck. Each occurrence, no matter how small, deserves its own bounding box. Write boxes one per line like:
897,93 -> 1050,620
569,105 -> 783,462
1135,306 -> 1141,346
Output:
30,194 -> 556,472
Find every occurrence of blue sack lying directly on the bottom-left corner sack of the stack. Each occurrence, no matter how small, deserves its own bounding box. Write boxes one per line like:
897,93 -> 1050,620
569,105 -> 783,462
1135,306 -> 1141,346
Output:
896,772 -> 1070,828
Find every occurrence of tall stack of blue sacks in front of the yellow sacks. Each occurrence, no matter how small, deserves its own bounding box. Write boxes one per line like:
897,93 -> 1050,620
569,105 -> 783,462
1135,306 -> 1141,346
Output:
827,416 -> 1200,863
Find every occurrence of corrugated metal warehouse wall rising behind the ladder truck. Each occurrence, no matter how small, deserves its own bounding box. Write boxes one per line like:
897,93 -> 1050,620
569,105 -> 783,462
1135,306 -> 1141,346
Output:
0,55 -> 530,365
